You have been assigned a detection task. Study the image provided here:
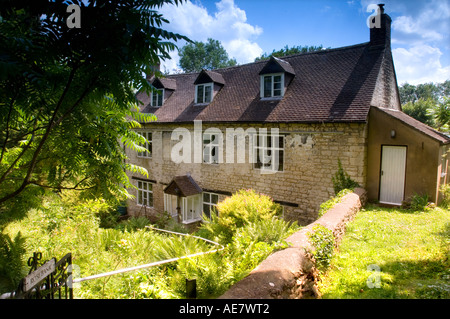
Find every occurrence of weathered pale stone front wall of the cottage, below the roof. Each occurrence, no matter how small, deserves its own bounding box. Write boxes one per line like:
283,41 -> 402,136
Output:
127,123 -> 367,225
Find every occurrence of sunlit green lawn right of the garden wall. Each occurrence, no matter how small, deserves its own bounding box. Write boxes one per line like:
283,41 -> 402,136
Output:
319,206 -> 450,299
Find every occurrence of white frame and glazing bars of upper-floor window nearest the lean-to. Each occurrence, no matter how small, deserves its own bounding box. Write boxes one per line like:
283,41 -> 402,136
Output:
253,133 -> 286,172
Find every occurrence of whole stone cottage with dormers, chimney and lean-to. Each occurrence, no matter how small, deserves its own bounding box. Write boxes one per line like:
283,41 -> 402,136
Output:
127,6 -> 450,224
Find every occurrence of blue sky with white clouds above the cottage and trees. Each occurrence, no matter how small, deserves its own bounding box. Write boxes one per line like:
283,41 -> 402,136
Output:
160,0 -> 450,85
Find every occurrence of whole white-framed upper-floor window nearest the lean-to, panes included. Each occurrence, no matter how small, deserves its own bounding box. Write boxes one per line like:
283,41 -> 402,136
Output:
253,134 -> 284,172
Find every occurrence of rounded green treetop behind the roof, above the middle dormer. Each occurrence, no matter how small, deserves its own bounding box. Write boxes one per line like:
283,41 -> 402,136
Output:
178,38 -> 237,72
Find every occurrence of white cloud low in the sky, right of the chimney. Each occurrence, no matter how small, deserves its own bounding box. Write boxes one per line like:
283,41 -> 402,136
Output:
392,44 -> 450,85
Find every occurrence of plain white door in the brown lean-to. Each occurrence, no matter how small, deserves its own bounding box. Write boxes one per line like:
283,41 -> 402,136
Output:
380,146 -> 406,205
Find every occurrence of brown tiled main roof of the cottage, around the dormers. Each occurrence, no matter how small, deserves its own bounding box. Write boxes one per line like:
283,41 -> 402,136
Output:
138,43 -> 390,123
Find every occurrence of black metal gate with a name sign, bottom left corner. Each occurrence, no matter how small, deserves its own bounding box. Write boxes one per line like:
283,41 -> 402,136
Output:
10,252 -> 73,299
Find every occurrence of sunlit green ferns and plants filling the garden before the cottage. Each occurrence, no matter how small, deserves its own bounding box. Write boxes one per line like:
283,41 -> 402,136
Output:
0,190 -> 298,299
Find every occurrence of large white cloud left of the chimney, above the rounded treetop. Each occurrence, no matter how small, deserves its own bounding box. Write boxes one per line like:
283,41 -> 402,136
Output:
160,0 -> 263,72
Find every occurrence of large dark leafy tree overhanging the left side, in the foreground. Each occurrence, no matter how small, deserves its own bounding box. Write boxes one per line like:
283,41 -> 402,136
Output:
0,0 -> 189,209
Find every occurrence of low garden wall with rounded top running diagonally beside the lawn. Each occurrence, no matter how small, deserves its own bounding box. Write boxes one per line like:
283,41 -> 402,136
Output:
219,188 -> 367,299
